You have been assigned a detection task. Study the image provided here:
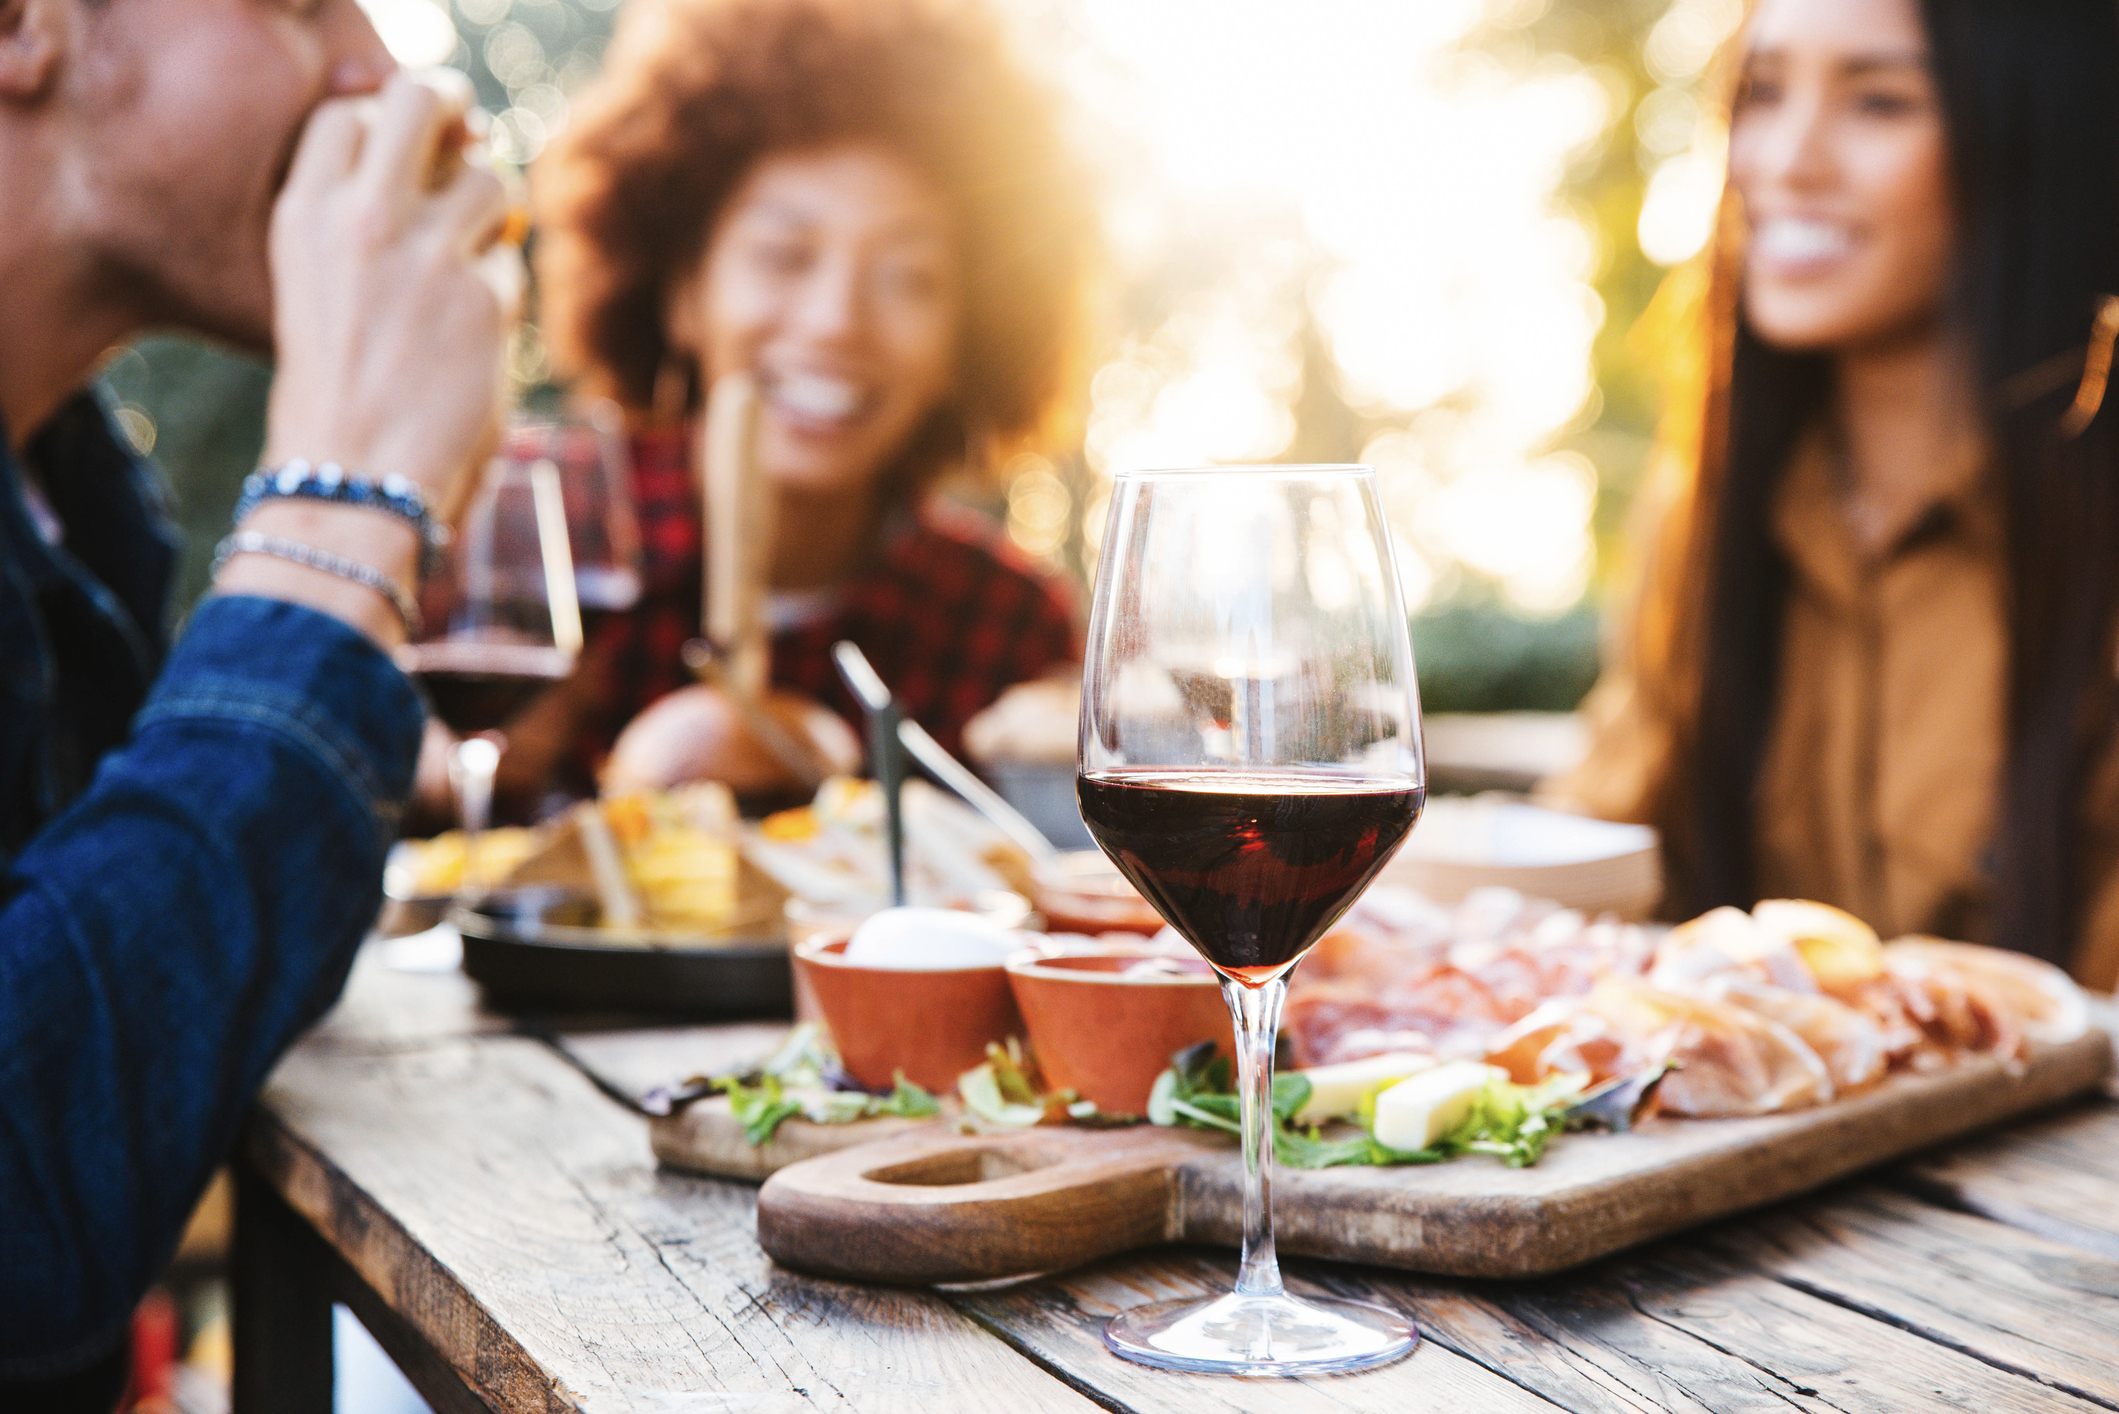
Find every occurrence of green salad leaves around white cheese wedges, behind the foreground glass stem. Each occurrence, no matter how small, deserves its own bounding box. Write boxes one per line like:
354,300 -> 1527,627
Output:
1148,1041 -> 1583,1168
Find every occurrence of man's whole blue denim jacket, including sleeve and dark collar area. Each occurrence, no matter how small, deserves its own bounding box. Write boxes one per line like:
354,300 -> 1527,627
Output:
0,396 -> 422,1386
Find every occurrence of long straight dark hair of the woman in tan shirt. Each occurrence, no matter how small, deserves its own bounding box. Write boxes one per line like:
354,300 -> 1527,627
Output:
1668,0 -> 2119,962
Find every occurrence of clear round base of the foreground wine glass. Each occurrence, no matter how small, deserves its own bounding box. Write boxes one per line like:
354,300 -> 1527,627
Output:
1104,1293 -> 1420,1376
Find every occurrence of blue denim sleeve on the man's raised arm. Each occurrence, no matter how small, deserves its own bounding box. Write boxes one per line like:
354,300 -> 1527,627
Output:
0,598 -> 422,1380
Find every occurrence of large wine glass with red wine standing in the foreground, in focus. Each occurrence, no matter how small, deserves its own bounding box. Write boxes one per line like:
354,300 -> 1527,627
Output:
1076,466 -> 1426,1374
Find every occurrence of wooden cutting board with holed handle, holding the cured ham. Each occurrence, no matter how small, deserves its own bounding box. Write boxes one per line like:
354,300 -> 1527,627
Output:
655,1030 -> 2113,1283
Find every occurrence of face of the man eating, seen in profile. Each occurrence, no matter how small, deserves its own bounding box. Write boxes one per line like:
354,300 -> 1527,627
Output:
64,0 -> 394,352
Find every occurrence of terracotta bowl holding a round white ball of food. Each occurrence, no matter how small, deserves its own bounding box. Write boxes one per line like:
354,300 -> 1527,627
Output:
795,929 -> 1023,1094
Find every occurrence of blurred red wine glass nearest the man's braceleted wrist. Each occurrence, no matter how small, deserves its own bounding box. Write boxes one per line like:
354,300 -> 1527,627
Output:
398,447 -> 581,864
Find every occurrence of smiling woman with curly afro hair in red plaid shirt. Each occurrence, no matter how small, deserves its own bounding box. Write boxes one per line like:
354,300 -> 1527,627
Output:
511,0 -> 1096,805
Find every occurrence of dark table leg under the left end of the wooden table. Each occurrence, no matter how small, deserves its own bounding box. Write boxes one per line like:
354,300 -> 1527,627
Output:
229,1162 -> 333,1414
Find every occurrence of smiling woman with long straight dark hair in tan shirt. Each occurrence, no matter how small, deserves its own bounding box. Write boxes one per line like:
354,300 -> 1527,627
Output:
1562,0 -> 2119,988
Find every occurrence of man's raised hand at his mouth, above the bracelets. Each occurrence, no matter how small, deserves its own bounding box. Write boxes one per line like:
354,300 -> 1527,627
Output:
265,74 -> 523,517
